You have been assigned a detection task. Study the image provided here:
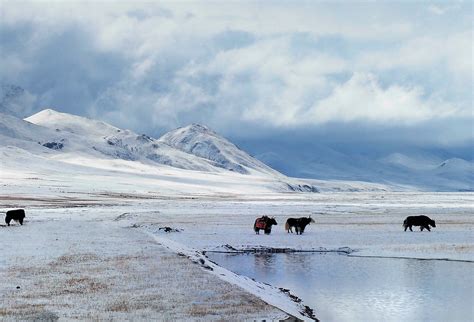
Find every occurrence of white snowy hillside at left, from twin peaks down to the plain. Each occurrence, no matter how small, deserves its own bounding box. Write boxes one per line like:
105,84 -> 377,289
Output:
0,109 -> 330,193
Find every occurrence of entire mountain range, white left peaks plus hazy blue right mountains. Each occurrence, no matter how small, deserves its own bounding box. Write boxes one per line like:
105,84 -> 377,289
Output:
0,85 -> 474,192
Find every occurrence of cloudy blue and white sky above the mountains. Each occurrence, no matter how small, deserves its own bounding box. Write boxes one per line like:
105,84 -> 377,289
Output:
0,0 -> 474,172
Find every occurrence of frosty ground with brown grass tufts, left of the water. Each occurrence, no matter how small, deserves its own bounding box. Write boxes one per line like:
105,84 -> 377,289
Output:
0,214 -> 288,321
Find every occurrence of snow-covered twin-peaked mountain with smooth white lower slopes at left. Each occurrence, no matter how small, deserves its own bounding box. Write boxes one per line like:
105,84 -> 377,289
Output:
0,109 -> 326,192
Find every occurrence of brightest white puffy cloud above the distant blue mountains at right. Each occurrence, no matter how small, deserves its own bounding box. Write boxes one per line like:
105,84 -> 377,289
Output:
305,73 -> 458,125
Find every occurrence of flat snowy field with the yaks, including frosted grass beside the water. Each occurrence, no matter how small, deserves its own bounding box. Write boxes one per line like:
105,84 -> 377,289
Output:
0,187 -> 474,319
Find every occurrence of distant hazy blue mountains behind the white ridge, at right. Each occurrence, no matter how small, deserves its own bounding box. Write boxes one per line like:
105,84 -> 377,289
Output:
250,143 -> 474,191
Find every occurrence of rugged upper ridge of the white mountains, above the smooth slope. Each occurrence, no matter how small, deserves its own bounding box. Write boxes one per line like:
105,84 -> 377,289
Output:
0,109 -> 318,192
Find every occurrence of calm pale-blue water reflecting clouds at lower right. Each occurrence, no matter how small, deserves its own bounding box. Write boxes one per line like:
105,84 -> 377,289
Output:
207,253 -> 474,321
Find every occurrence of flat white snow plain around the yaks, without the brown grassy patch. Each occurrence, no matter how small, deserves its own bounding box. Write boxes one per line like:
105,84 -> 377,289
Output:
0,187 -> 474,318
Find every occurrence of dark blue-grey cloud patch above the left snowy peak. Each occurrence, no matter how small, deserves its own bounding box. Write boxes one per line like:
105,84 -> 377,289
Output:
2,24 -> 126,114
